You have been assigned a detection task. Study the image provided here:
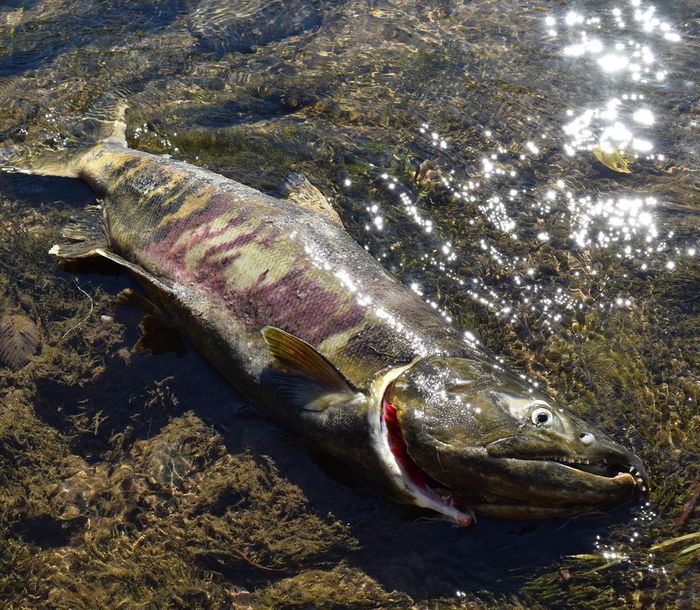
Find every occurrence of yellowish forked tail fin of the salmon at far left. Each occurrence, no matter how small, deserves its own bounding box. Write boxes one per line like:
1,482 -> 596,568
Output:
0,91 -> 127,178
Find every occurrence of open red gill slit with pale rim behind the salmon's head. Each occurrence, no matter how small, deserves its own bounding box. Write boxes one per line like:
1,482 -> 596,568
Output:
380,383 -> 476,527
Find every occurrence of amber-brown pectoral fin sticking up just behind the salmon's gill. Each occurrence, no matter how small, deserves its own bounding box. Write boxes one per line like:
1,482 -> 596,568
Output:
262,326 -> 363,411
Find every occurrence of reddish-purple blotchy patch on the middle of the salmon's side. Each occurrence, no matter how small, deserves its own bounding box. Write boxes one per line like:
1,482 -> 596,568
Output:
140,194 -> 365,344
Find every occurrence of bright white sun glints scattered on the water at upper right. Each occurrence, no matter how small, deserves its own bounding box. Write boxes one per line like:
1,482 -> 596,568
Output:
352,1 -> 695,346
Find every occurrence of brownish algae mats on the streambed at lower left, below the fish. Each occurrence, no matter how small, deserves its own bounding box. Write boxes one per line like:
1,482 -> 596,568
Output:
0,207 -> 355,608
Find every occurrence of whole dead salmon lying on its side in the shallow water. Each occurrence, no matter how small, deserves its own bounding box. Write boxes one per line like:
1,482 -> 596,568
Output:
6,100 -> 646,526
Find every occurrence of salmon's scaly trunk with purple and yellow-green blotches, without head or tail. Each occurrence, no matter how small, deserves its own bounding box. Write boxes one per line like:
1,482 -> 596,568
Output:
80,145 -> 469,380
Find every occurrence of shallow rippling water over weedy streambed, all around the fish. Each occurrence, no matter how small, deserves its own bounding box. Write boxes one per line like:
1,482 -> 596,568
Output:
0,0 -> 700,608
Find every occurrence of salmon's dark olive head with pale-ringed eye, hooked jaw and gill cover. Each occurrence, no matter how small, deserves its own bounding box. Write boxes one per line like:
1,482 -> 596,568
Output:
380,357 -> 648,525
